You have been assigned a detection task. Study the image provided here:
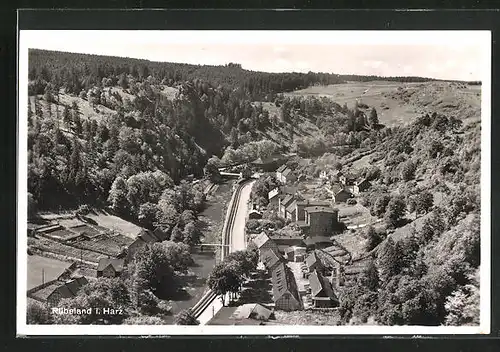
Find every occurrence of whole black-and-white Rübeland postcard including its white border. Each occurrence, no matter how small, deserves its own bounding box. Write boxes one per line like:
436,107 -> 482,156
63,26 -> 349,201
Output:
17,30 -> 491,335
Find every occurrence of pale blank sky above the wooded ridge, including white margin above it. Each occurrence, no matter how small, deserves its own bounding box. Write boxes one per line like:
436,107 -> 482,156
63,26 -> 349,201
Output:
20,31 -> 491,81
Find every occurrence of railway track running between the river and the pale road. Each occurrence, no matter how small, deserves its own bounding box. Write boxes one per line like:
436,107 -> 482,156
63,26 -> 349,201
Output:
191,180 -> 251,319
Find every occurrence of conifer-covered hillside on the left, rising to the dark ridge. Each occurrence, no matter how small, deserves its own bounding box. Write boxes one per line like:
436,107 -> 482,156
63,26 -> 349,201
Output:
28,50 -> 394,214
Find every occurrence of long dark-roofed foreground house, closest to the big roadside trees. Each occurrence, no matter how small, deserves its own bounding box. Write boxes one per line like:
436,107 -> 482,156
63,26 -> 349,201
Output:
271,263 -> 302,311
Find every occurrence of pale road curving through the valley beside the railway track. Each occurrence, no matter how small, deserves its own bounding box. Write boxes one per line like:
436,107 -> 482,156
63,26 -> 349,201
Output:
198,181 -> 255,325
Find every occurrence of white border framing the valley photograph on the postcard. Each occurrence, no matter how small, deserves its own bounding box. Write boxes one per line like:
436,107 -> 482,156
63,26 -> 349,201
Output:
16,30 -> 491,337
